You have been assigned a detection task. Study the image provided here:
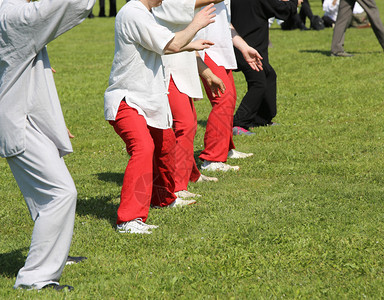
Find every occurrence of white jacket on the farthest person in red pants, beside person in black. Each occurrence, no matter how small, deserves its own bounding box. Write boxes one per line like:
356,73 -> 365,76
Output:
195,0 -> 237,70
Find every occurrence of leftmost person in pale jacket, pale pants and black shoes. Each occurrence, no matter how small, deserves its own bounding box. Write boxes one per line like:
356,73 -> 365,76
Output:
0,0 -> 95,290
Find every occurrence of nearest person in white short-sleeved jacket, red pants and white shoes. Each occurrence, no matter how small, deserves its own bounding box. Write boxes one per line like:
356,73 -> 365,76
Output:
104,0 -> 215,234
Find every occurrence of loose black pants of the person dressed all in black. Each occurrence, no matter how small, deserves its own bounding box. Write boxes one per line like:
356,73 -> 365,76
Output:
233,65 -> 276,129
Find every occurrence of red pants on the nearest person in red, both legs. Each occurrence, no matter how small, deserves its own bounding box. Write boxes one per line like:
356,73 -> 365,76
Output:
109,101 -> 176,224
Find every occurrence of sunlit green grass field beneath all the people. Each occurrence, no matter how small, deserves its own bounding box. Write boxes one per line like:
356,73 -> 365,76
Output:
0,0 -> 384,299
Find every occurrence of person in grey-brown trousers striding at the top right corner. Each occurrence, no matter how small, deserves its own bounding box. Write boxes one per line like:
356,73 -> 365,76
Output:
331,0 -> 384,57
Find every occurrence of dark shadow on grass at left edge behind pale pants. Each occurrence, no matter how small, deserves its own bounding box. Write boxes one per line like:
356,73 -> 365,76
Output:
0,247 -> 28,277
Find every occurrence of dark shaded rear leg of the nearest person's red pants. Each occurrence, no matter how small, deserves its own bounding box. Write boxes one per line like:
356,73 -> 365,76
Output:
148,126 -> 177,207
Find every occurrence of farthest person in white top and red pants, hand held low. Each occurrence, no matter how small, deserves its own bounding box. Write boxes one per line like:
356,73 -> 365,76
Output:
196,0 -> 261,171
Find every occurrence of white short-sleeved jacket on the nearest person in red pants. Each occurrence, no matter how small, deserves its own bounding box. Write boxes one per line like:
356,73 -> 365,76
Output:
104,0 -> 175,129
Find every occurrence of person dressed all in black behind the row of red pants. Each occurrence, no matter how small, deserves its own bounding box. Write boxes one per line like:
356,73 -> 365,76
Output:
231,0 -> 301,132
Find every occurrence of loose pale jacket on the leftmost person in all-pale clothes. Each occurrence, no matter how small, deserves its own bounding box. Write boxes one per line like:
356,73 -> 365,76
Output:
0,0 -> 95,157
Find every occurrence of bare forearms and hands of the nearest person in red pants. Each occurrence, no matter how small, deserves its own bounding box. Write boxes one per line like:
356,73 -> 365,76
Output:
164,4 -> 216,54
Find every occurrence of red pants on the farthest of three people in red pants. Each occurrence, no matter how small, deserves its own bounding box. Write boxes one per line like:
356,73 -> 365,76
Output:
199,54 -> 236,162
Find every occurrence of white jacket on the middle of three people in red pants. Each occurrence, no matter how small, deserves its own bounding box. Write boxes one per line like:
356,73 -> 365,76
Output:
152,0 -> 203,98
